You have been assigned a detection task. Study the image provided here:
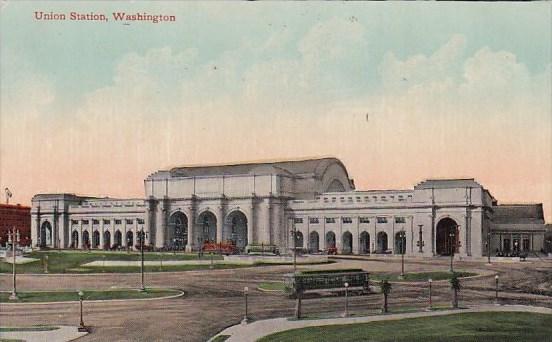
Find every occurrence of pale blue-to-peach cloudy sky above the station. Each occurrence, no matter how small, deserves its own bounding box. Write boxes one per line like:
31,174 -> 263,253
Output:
0,1 -> 552,221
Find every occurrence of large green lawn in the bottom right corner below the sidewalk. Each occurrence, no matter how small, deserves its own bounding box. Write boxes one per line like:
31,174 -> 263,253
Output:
259,312 -> 552,342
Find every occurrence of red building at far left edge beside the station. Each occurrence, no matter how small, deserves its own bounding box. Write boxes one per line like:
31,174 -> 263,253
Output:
0,204 -> 31,246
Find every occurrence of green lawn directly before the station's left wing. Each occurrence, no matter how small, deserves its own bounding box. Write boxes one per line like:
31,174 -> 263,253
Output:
0,251 -> 224,273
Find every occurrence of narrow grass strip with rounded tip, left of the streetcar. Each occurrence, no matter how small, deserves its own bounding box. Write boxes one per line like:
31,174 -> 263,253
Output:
0,289 -> 180,303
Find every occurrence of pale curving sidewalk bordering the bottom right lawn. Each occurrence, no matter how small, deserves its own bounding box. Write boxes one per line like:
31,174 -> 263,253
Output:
209,305 -> 552,342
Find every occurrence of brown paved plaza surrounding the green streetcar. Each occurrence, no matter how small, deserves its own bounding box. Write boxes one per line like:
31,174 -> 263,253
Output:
0,257 -> 552,341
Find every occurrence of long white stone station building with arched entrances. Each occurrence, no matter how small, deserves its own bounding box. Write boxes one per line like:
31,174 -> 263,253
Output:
31,158 -> 546,257
